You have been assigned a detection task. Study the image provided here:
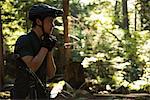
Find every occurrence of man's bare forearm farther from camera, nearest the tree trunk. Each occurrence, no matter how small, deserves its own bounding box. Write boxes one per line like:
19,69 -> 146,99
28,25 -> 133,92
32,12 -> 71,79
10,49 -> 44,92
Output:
47,52 -> 56,79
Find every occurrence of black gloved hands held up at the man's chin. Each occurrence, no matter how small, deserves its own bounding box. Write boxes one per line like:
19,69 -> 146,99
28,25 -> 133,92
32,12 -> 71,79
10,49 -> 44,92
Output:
41,34 -> 57,51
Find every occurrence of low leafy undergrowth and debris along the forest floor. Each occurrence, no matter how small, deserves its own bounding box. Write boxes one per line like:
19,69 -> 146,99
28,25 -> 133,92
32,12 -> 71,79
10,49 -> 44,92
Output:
0,80 -> 150,100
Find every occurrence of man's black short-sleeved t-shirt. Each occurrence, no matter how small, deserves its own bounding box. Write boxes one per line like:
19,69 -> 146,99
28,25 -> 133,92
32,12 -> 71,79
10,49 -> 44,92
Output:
14,31 -> 46,98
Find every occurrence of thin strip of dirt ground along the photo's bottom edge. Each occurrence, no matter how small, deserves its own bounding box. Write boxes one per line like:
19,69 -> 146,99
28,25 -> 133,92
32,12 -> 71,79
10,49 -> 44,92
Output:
0,91 -> 150,100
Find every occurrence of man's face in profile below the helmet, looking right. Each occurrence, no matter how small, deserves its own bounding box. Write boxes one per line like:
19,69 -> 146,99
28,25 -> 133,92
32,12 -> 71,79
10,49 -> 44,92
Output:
44,17 -> 55,34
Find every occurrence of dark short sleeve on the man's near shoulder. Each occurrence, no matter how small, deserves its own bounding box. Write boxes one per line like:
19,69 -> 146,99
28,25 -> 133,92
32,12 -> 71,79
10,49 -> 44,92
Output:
14,35 -> 33,57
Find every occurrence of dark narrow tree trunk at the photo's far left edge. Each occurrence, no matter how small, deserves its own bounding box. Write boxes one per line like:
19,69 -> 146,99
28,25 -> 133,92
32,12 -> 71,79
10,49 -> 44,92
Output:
0,7 -> 4,91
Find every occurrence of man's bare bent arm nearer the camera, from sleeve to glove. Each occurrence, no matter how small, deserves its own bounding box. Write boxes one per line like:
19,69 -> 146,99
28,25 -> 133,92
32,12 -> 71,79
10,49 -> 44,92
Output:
21,47 -> 48,72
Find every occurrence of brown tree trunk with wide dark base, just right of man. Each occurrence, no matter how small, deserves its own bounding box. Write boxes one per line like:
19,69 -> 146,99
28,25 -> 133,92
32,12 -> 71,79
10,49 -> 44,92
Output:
63,0 -> 84,88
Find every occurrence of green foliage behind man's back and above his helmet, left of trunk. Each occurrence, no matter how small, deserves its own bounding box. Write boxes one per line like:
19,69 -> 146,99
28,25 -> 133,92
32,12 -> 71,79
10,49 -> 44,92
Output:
0,0 -> 62,53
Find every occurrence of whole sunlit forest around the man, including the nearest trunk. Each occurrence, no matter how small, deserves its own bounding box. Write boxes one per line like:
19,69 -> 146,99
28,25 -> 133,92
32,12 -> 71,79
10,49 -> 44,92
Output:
0,0 -> 150,100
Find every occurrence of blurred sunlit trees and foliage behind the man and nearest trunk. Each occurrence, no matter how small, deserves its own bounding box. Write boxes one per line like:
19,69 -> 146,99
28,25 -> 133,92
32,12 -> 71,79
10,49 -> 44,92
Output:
0,0 -> 150,93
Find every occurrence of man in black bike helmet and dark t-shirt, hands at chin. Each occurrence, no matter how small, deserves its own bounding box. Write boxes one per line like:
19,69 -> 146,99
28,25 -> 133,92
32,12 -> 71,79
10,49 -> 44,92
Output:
14,4 -> 63,99
